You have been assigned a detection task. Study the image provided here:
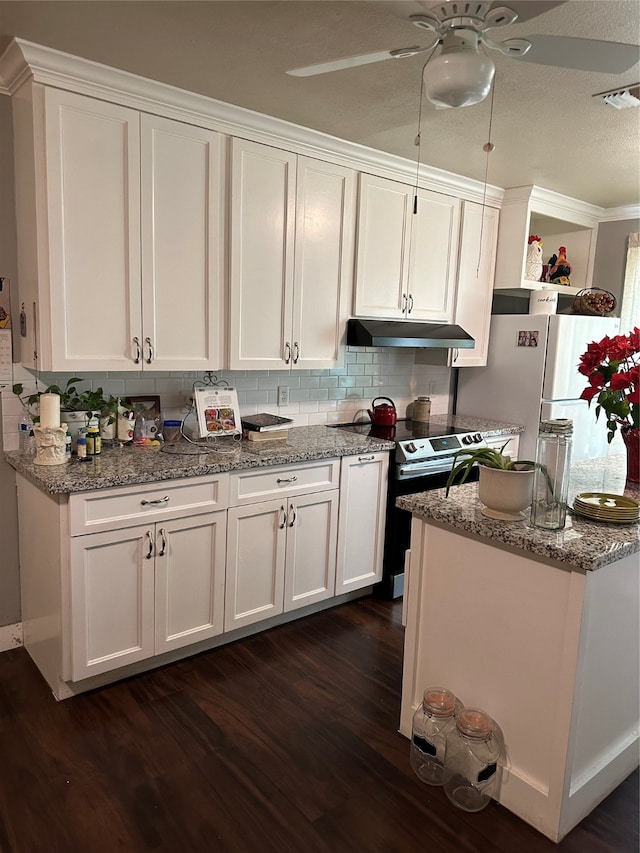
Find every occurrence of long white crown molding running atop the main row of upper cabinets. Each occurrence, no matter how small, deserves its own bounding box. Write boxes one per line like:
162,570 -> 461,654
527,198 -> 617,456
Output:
0,38 -> 504,207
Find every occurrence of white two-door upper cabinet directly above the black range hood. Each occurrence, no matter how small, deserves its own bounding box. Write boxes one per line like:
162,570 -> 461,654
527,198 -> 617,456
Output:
354,174 -> 460,322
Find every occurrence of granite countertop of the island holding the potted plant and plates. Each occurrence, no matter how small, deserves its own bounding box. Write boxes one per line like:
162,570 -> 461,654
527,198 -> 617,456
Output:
396,456 -> 640,571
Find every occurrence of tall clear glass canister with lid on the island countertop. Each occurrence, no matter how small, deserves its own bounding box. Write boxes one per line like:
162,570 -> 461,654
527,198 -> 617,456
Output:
531,418 -> 573,530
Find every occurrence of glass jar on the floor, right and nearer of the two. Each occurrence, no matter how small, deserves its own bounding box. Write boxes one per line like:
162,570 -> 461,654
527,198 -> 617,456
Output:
442,708 -> 504,812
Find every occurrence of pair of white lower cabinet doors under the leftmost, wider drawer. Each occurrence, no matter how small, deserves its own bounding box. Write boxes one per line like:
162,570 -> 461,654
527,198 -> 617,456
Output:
70,511 -> 226,681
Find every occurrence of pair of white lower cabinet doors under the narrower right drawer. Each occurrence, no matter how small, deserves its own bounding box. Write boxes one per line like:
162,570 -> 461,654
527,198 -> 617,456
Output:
225,489 -> 338,631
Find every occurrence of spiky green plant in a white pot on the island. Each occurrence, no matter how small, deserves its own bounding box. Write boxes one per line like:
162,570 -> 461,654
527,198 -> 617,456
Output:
445,443 -> 536,521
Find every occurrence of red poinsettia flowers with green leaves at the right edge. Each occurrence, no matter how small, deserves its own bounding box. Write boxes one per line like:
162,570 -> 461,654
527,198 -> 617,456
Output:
578,326 -> 640,442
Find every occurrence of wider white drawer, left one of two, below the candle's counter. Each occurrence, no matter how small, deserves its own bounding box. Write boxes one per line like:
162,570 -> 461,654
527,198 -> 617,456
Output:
69,474 -> 229,536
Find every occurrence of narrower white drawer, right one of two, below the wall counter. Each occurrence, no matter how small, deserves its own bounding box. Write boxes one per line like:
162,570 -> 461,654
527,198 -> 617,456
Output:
229,459 -> 340,506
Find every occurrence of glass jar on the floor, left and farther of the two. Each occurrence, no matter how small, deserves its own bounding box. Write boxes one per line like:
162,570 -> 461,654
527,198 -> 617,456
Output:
411,687 -> 462,785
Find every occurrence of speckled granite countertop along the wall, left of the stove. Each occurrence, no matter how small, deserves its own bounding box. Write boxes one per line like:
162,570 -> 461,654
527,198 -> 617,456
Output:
5,426 -> 394,495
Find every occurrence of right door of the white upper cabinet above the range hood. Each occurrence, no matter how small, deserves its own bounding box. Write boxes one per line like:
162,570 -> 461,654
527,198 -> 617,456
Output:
407,190 -> 460,322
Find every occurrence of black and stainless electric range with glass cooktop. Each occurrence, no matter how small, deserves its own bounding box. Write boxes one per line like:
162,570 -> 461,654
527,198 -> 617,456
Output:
331,420 -> 487,598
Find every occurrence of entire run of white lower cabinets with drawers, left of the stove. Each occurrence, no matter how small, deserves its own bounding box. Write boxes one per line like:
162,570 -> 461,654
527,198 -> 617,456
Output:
17,453 -> 389,699
